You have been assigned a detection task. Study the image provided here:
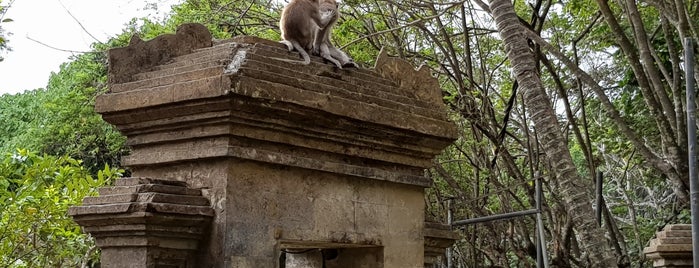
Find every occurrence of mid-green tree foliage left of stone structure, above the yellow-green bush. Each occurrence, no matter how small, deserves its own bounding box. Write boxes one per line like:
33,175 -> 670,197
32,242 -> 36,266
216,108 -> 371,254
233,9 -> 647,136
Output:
0,52 -> 126,172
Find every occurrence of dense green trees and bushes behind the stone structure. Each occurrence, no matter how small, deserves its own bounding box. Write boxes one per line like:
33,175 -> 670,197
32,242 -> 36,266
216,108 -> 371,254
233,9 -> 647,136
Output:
0,0 -> 699,267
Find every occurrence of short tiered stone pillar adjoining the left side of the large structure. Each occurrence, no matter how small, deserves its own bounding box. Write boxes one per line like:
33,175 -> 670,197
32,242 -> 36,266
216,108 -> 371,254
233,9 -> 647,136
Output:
68,178 -> 214,268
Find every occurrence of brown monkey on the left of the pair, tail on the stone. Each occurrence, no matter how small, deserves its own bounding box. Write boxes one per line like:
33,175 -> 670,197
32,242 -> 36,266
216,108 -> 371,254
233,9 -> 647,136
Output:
279,0 -> 342,68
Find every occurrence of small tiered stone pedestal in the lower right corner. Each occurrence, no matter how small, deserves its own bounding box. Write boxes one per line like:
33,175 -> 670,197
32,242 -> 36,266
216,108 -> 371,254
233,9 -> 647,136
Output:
643,224 -> 693,268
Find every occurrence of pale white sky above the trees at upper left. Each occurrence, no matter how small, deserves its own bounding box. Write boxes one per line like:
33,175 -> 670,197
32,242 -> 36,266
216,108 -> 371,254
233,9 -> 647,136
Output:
0,0 -> 180,95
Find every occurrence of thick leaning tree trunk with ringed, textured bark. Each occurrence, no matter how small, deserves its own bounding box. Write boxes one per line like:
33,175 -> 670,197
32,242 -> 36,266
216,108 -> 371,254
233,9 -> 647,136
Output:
490,0 -> 617,268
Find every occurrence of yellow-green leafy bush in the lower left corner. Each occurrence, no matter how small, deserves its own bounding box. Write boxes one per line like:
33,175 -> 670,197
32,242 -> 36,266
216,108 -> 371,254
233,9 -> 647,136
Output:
0,150 -> 122,267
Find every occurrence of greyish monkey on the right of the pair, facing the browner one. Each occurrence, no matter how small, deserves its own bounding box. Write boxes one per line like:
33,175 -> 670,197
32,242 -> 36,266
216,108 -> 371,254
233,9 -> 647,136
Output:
313,0 -> 359,69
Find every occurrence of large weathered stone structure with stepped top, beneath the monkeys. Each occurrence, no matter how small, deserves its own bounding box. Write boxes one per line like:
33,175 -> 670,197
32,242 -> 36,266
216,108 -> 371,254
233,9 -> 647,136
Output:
71,24 -> 457,268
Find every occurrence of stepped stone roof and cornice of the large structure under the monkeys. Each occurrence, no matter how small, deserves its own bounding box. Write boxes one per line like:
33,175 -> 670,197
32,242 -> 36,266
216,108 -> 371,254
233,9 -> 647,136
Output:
96,34 -> 456,191
